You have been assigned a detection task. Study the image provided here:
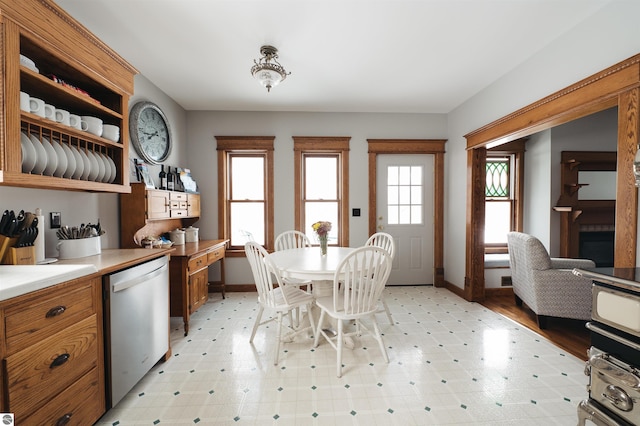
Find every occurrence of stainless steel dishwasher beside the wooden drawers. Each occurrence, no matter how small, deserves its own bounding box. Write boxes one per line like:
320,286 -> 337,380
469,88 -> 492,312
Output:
104,256 -> 169,408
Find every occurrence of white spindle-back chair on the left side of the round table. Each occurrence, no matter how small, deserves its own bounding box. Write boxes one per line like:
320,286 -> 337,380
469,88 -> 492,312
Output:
244,241 -> 315,365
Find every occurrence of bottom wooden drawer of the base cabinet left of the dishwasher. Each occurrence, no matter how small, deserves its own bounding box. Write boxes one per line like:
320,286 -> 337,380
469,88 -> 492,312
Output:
21,368 -> 106,425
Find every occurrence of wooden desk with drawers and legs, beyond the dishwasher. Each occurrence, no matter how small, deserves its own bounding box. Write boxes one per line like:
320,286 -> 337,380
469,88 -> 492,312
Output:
169,240 -> 228,336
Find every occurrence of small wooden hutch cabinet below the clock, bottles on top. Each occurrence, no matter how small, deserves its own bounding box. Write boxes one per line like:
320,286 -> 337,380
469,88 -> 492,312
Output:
120,183 -> 200,248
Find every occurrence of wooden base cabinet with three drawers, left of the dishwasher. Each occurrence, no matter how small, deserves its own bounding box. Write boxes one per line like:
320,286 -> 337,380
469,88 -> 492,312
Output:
0,277 -> 106,425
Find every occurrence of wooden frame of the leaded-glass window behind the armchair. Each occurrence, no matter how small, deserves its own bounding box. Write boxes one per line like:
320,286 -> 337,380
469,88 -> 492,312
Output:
483,138 -> 527,254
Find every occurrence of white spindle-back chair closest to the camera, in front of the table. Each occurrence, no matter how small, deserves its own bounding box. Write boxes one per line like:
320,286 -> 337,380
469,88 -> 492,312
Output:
313,246 -> 391,377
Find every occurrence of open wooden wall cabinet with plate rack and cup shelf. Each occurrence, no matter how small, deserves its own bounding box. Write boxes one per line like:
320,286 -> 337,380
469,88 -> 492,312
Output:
0,0 -> 137,193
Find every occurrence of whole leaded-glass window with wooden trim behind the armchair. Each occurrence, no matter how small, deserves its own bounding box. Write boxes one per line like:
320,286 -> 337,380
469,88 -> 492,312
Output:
484,141 -> 524,253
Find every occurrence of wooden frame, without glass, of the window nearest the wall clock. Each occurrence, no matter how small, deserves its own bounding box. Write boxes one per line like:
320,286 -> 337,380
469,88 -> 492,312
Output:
215,136 -> 275,257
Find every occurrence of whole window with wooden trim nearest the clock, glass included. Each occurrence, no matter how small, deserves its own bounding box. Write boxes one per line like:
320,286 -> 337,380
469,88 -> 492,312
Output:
216,136 -> 275,256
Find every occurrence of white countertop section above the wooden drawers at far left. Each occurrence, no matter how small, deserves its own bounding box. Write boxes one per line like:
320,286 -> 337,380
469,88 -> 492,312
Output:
0,264 -> 98,301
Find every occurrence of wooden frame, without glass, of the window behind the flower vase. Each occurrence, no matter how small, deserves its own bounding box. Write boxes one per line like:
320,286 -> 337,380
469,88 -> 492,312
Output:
293,136 -> 351,247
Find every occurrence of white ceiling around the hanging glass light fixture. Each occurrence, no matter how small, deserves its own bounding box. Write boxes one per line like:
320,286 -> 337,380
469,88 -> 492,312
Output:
57,0 -> 613,113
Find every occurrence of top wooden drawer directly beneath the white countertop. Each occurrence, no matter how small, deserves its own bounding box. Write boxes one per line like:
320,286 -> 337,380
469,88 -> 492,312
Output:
4,278 -> 100,355
